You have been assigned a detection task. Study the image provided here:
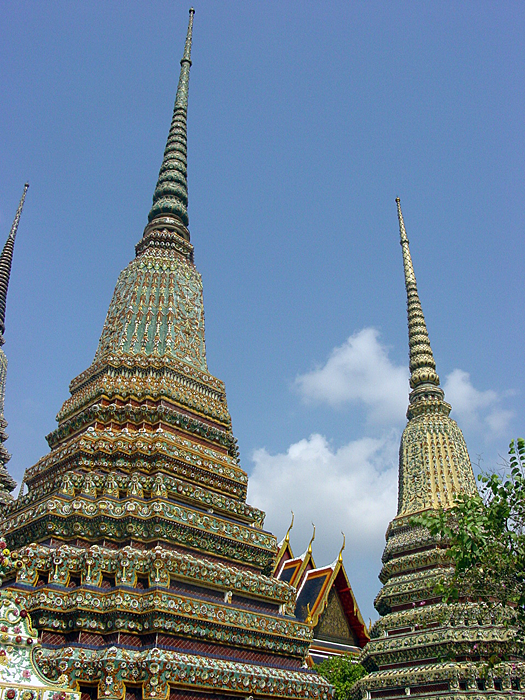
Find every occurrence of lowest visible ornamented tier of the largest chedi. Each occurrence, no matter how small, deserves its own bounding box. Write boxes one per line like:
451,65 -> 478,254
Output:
36,647 -> 332,700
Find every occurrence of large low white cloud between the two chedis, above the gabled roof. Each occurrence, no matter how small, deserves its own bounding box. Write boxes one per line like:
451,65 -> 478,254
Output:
248,431 -> 399,616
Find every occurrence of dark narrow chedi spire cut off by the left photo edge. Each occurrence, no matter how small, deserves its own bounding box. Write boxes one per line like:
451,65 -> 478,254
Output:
0,182 -> 29,505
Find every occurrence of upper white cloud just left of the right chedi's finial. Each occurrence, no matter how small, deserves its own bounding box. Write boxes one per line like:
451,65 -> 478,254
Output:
295,328 -> 408,425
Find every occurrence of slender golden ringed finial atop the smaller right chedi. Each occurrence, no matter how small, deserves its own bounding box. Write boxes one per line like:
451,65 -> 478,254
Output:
396,197 -> 443,402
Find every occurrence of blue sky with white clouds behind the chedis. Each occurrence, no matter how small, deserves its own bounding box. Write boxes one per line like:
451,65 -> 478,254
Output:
0,0 -> 525,618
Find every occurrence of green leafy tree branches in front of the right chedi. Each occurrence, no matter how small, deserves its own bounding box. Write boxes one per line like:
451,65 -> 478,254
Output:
415,438 -> 525,645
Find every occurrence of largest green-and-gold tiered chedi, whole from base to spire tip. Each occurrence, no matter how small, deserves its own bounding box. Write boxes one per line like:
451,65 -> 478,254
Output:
2,10 -> 330,700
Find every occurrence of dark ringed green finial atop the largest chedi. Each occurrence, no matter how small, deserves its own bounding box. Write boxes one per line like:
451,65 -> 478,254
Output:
148,7 -> 195,231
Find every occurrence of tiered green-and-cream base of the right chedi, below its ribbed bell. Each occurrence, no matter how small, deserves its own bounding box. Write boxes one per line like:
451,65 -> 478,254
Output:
352,516 -> 525,700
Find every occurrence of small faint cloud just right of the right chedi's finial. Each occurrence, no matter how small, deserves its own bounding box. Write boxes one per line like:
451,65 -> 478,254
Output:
443,369 -> 514,437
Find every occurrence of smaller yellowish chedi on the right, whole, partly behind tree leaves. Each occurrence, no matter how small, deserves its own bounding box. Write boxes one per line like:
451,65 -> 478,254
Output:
352,199 -> 525,699
